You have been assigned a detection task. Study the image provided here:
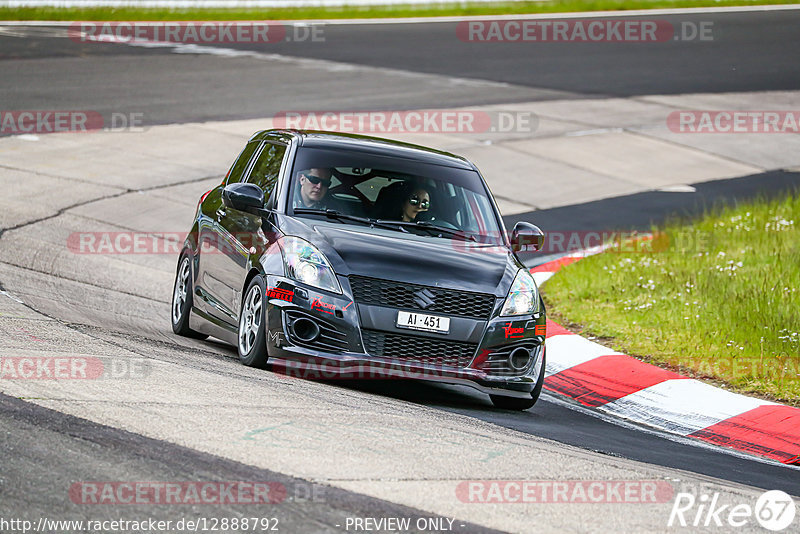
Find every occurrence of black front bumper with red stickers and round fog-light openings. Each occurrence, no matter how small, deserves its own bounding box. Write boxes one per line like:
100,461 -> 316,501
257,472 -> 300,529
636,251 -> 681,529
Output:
267,276 -> 545,398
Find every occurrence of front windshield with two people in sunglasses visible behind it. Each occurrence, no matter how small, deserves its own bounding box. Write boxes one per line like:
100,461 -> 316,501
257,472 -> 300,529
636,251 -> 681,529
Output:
288,147 -> 502,245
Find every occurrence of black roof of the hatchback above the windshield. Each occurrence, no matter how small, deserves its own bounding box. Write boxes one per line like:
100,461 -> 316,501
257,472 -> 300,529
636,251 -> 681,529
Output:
252,130 -> 475,170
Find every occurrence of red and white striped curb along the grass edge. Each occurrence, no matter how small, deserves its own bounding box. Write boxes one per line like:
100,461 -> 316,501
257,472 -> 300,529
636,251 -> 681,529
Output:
531,253 -> 800,465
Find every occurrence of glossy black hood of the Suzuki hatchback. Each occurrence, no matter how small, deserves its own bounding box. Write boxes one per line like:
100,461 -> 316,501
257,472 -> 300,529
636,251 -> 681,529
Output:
284,218 -> 522,297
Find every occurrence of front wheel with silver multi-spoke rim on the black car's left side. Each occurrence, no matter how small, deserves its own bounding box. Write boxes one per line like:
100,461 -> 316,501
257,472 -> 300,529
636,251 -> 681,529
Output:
238,275 -> 268,368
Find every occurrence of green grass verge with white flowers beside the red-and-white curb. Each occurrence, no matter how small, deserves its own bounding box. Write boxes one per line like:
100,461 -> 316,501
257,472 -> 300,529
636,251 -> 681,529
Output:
543,192 -> 800,406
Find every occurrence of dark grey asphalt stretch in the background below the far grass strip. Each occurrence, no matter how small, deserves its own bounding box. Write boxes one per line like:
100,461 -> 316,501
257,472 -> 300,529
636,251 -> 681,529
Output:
0,10 -> 800,124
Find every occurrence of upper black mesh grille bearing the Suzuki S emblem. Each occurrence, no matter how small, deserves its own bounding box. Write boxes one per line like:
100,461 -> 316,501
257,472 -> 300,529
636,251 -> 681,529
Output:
350,275 -> 495,320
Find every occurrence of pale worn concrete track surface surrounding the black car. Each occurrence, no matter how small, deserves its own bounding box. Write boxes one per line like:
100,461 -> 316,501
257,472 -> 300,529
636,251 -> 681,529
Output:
0,90 -> 800,532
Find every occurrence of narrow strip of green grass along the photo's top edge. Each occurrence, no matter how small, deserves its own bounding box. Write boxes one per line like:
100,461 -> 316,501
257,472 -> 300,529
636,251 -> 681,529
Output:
0,0 -> 798,21
